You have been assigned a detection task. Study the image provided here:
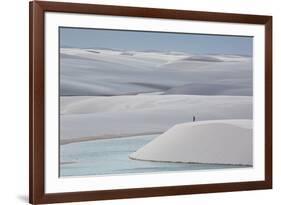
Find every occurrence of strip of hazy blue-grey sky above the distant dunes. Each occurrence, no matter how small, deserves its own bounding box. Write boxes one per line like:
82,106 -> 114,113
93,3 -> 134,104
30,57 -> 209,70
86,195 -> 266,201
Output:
60,27 -> 253,56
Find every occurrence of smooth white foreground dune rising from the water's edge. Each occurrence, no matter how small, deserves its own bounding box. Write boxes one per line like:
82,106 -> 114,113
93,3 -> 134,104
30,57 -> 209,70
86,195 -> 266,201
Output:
130,120 -> 253,165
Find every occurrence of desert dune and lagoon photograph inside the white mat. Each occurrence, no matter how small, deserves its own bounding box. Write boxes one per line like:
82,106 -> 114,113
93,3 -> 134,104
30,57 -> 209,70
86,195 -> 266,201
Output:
58,27 -> 253,177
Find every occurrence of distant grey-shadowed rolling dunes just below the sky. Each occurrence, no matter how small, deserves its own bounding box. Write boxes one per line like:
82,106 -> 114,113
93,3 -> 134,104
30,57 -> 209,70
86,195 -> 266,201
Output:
60,48 -> 252,96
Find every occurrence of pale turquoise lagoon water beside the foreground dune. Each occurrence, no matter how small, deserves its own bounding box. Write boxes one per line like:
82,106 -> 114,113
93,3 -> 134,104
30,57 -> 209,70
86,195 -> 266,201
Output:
60,135 -> 246,176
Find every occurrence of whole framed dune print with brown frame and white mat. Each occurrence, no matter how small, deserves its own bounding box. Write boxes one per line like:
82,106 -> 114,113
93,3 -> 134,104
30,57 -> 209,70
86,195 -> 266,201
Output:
30,1 -> 272,204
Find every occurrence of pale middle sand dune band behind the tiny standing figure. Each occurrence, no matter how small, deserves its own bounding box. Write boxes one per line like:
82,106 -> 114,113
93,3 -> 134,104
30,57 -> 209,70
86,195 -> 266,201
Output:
60,95 -> 252,144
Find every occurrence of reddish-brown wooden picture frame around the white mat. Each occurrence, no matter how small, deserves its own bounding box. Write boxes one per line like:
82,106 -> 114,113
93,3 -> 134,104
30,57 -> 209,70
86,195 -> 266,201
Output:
29,1 -> 272,204
